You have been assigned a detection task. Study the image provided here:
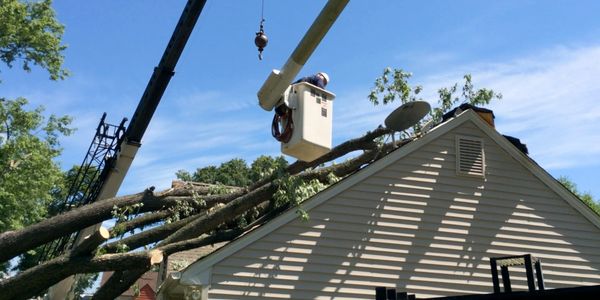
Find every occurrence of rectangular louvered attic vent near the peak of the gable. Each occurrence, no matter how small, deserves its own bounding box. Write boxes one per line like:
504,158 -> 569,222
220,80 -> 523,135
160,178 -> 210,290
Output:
456,136 -> 485,177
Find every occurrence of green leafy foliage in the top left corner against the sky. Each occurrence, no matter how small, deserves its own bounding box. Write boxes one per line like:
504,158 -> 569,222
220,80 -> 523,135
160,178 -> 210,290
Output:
0,0 -> 68,80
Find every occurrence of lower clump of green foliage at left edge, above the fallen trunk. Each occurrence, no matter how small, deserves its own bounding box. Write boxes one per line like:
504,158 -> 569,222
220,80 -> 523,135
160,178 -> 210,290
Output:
0,98 -> 72,231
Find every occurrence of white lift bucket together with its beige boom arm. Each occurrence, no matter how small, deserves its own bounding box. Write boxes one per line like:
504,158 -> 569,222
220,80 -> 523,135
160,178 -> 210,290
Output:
257,0 -> 350,161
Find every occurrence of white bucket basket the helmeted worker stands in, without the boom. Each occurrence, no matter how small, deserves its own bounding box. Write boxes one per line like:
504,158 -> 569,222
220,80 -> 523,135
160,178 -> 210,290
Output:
281,82 -> 335,162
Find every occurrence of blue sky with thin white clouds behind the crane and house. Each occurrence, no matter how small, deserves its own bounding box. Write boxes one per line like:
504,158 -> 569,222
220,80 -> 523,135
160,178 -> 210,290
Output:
0,0 -> 600,199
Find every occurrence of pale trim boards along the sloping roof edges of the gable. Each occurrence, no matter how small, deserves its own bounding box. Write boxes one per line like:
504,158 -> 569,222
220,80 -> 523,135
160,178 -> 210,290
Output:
160,109 -> 600,291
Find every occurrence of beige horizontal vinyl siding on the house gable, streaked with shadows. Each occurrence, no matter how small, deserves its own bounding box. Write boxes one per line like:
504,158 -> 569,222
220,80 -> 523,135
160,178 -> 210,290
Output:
209,122 -> 600,299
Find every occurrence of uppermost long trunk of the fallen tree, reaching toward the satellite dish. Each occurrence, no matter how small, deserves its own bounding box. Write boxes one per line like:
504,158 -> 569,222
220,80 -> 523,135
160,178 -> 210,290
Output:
0,127 -> 389,262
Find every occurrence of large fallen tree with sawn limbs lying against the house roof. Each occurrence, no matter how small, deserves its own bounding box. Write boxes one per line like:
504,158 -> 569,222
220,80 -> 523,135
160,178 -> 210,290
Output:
0,127 -> 400,299
